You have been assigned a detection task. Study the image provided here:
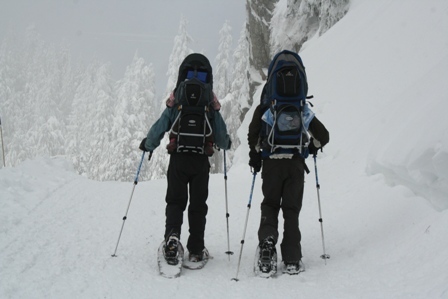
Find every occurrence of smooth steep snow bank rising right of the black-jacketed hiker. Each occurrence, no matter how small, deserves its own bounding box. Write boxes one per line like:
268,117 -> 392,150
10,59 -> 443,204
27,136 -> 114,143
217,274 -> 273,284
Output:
302,0 -> 448,211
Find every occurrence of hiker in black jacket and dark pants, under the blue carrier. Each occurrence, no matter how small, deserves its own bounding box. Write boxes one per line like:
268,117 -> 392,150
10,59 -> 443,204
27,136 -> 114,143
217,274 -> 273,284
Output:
248,99 -> 329,274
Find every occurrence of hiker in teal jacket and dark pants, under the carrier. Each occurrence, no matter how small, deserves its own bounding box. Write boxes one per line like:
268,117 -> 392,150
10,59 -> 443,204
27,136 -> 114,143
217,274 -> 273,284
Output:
140,54 -> 231,264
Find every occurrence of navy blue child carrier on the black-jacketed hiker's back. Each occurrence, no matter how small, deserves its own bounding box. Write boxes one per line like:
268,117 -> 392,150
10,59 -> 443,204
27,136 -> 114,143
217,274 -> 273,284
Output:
260,50 -> 314,158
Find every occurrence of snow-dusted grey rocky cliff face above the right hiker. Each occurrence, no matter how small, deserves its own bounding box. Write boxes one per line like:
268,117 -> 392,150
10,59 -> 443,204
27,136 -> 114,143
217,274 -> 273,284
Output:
246,0 -> 350,101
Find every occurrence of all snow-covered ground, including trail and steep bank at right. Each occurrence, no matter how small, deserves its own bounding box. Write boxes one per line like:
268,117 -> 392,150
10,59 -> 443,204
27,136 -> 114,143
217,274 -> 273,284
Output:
0,0 -> 448,298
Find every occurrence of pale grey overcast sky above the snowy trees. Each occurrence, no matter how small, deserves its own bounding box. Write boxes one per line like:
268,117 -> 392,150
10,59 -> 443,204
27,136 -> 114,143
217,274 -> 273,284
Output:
0,0 -> 246,96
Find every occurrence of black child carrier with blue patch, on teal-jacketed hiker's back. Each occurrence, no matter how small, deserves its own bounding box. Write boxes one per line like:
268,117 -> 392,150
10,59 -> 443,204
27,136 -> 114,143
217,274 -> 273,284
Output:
167,54 -> 214,156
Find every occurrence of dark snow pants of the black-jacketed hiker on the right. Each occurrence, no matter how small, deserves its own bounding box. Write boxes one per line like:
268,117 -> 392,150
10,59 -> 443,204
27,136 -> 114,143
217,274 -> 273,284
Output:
258,157 -> 305,263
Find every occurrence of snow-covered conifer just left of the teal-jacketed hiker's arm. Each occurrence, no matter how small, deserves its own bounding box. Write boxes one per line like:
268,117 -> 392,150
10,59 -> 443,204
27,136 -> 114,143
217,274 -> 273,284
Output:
107,53 -> 159,181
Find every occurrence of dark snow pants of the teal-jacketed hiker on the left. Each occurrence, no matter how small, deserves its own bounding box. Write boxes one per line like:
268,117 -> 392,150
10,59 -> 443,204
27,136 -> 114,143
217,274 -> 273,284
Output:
165,154 -> 210,253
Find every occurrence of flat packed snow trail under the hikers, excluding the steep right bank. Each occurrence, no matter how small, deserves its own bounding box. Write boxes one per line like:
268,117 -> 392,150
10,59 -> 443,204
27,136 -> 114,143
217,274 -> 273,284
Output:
0,157 -> 448,298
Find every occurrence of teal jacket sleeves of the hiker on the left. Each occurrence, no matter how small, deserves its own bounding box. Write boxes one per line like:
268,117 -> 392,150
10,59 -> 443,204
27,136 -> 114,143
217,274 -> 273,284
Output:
145,106 -> 231,152
